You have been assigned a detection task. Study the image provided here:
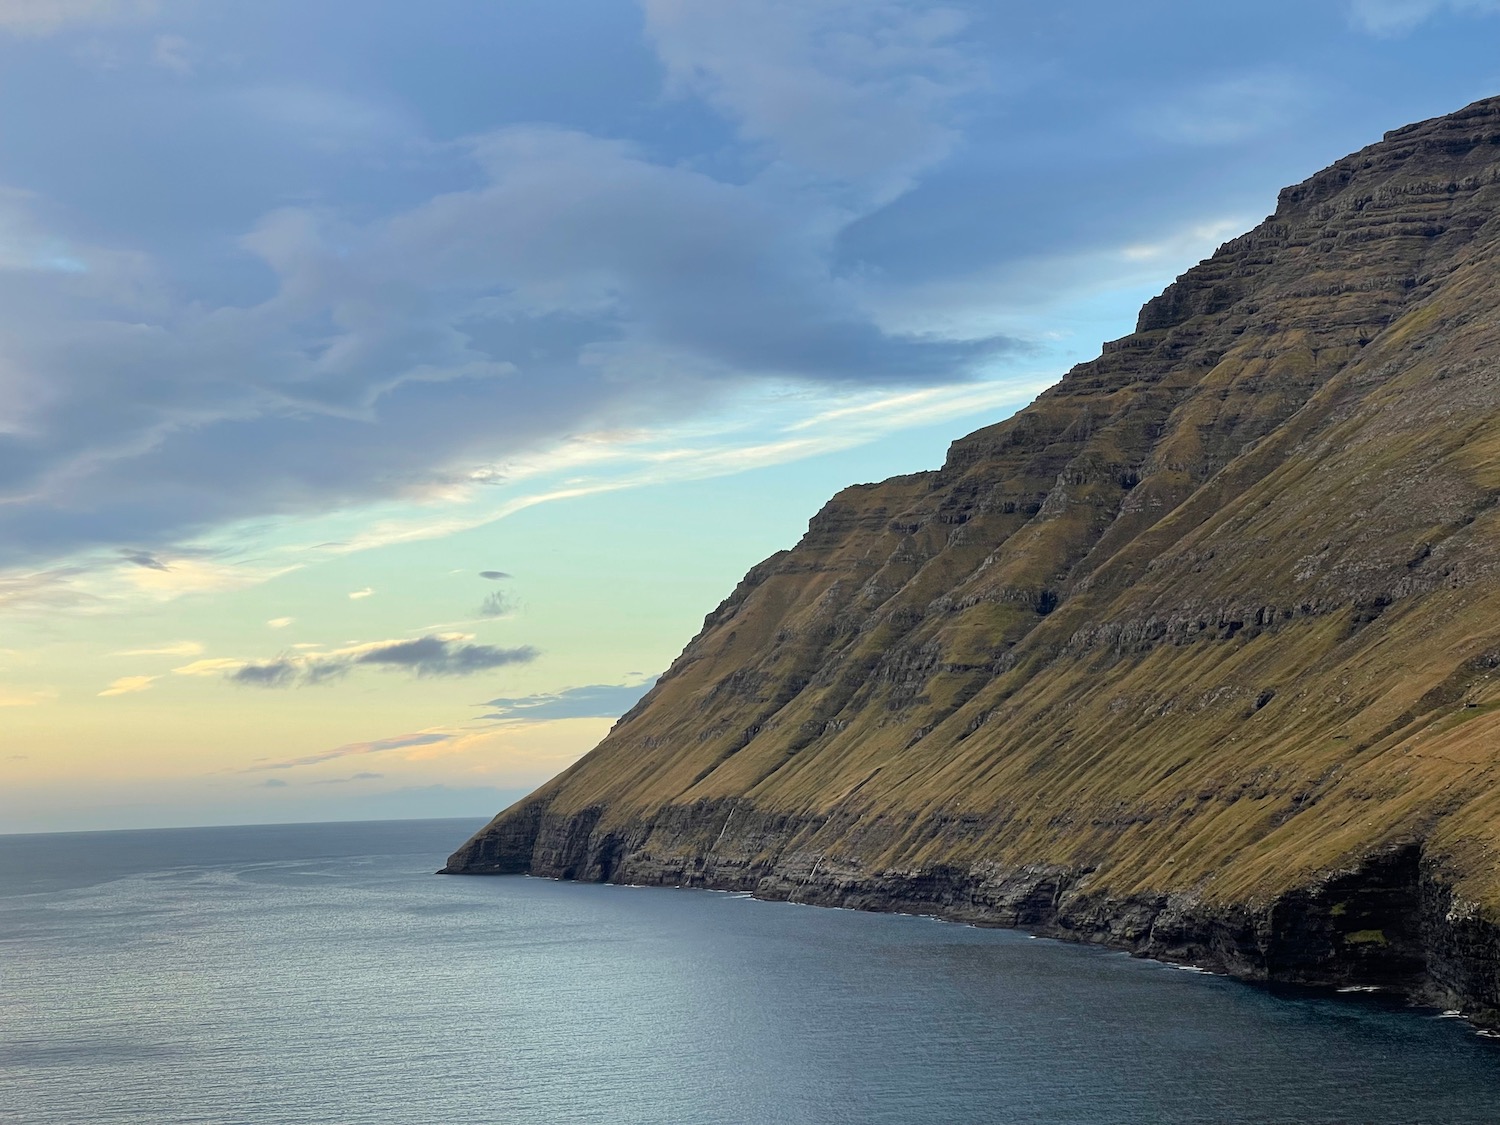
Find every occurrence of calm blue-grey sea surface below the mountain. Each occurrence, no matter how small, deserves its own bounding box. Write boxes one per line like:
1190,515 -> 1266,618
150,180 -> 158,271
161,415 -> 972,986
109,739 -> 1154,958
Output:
0,821 -> 1500,1125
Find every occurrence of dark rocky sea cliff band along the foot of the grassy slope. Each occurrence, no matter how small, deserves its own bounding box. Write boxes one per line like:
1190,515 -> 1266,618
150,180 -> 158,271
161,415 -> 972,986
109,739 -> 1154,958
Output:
438,800 -> 1500,1034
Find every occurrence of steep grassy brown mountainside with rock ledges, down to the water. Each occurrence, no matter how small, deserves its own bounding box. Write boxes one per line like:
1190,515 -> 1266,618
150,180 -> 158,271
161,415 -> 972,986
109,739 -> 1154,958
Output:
446,99 -> 1500,1019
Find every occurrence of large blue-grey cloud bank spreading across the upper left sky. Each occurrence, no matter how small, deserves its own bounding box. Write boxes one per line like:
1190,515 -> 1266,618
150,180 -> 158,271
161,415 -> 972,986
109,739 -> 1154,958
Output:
0,2 -> 1014,576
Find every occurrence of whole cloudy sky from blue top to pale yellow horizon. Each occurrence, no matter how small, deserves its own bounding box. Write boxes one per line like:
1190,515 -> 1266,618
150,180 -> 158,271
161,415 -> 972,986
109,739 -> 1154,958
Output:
0,0 -> 1500,833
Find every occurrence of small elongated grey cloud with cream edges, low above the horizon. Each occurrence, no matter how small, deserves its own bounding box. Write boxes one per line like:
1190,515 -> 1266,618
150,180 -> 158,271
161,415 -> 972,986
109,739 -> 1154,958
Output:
226,633 -> 540,687
